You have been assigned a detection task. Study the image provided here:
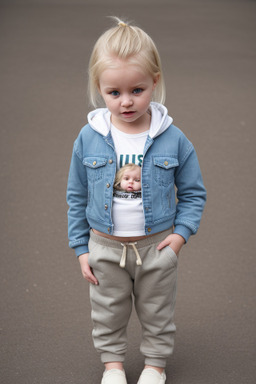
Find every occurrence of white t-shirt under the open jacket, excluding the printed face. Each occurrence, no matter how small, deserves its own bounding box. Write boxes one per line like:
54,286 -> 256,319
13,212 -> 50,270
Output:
111,124 -> 149,237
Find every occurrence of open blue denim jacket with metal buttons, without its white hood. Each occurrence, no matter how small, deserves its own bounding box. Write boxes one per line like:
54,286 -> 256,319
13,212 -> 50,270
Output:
67,103 -> 206,256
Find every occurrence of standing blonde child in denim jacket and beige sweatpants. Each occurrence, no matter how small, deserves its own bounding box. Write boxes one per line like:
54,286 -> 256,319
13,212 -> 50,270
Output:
67,19 -> 206,384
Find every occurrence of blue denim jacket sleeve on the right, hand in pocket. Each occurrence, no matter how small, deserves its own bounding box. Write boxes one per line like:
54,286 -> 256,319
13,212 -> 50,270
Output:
174,137 -> 206,241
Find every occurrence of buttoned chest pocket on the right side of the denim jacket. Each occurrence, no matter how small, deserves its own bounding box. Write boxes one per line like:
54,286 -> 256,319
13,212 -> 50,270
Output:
153,156 -> 179,186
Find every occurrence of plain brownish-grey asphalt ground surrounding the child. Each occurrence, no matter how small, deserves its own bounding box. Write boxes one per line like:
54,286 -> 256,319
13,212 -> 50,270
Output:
0,0 -> 256,384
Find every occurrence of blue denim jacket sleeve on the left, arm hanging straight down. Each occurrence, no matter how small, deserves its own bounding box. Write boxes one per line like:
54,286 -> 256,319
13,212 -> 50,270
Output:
67,141 -> 90,256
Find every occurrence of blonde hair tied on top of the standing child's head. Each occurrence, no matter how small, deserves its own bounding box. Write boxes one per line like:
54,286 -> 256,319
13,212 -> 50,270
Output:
88,17 -> 165,107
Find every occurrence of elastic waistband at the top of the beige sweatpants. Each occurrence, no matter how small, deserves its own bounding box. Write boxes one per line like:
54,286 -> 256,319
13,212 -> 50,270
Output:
90,227 -> 173,250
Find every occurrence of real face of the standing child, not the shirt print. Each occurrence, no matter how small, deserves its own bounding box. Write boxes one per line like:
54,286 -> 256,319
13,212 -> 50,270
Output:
99,58 -> 158,133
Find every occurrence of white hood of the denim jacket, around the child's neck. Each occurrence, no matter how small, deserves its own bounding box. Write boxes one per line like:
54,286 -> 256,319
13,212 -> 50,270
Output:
88,102 -> 173,139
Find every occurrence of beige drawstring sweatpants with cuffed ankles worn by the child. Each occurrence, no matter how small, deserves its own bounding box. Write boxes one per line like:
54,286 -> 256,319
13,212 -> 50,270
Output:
89,230 -> 177,367
